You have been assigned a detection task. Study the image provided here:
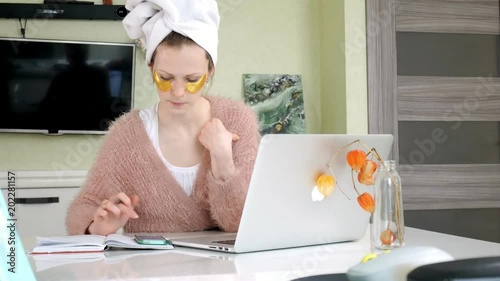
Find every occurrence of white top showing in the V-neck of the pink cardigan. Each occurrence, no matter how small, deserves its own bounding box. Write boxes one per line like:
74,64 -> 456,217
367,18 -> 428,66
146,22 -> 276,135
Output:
139,103 -> 199,195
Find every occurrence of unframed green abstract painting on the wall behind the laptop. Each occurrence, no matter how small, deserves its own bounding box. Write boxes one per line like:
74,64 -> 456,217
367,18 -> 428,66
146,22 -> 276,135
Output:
243,74 -> 306,135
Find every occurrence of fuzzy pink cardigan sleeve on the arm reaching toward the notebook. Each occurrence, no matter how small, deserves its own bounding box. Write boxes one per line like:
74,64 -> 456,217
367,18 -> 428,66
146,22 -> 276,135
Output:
65,114 -> 137,235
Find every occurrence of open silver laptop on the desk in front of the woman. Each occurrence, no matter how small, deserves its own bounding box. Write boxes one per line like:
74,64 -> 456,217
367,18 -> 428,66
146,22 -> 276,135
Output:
171,134 -> 394,253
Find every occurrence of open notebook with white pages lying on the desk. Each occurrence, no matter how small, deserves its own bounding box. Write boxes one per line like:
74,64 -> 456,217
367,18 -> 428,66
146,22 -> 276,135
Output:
31,234 -> 174,254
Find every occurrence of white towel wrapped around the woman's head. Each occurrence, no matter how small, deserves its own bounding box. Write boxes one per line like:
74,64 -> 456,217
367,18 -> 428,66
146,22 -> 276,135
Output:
123,0 -> 220,65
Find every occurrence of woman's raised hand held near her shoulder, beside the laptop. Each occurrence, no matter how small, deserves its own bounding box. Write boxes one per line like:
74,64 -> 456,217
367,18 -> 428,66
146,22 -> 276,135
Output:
198,118 -> 240,180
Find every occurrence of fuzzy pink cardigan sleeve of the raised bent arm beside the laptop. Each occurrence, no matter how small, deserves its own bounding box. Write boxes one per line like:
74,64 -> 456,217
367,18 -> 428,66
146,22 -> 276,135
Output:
206,103 -> 260,232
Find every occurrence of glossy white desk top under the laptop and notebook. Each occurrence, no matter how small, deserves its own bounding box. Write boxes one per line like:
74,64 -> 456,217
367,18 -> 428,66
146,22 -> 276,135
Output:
29,228 -> 500,281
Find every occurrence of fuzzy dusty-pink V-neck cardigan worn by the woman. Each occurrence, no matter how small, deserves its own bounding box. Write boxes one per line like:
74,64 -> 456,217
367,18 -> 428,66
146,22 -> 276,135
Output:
66,97 -> 260,235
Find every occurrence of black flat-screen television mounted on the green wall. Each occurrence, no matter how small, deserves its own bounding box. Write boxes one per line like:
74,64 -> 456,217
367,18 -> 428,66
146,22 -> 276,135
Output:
0,38 -> 136,134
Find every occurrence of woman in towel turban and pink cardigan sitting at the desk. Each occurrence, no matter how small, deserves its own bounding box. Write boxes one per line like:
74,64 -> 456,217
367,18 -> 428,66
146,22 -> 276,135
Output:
66,0 -> 260,235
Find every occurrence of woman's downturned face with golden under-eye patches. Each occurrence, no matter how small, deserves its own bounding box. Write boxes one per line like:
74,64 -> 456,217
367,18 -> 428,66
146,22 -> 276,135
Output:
152,45 -> 212,112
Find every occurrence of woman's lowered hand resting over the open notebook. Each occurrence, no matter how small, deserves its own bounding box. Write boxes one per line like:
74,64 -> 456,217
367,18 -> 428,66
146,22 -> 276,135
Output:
88,192 -> 139,235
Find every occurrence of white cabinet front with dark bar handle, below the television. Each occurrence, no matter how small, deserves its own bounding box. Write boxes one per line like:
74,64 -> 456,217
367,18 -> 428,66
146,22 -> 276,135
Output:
2,187 -> 80,250
